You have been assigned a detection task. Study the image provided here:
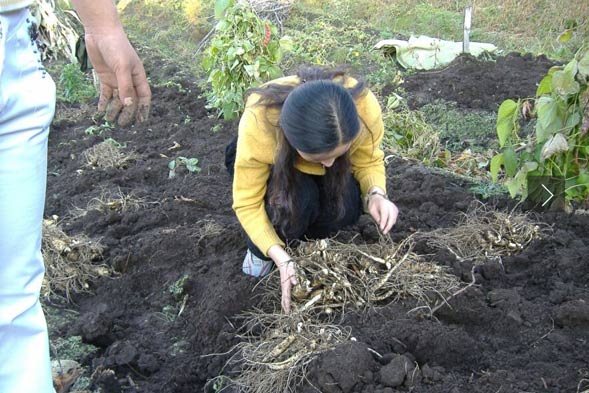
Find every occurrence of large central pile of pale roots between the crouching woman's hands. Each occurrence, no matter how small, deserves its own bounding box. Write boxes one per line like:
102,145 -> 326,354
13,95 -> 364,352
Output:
266,237 -> 461,315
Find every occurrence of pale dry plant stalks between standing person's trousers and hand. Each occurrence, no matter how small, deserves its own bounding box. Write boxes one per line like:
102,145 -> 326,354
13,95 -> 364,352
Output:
31,0 -> 83,63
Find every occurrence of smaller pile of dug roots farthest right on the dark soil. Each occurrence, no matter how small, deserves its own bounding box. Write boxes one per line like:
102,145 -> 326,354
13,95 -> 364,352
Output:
417,203 -> 545,263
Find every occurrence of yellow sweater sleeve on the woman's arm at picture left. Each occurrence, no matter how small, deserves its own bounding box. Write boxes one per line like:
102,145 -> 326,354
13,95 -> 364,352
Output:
233,102 -> 284,255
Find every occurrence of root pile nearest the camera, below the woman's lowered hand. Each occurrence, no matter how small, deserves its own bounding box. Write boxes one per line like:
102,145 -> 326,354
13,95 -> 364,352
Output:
212,310 -> 351,393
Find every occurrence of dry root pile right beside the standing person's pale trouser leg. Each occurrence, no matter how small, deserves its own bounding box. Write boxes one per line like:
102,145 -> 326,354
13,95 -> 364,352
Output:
41,220 -> 112,301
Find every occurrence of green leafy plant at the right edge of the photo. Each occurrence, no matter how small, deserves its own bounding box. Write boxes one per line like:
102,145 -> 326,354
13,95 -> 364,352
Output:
490,49 -> 589,202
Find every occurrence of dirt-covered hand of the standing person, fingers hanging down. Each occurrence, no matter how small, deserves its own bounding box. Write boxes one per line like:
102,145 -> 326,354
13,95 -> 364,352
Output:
85,29 -> 151,127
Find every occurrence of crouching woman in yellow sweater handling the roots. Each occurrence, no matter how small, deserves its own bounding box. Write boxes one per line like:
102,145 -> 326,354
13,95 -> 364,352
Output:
226,68 -> 398,312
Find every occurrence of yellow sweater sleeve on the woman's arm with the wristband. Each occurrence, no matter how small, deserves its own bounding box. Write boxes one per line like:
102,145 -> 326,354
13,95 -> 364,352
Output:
350,91 -> 386,195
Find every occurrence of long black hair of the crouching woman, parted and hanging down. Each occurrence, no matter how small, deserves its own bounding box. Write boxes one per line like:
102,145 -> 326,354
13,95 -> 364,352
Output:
249,67 -> 366,234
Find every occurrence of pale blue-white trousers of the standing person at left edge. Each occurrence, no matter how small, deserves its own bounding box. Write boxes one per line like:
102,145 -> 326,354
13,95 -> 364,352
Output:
0,9 -> 55,393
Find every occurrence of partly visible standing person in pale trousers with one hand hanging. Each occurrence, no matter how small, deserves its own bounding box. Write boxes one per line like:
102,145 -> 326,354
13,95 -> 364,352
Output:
0,0 -> 151,393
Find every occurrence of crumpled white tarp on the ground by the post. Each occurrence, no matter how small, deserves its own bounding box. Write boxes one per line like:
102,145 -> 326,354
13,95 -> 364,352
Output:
374,35 -> 497,70
